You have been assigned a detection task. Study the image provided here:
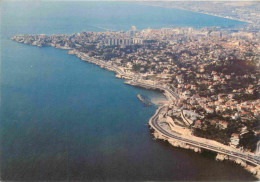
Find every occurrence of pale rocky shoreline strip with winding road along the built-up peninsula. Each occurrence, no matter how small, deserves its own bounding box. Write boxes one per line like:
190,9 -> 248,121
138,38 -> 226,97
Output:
9,38 -> 260,179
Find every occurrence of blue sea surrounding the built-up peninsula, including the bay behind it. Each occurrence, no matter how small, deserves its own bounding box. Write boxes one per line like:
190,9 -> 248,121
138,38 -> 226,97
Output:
0,1 -> 255,181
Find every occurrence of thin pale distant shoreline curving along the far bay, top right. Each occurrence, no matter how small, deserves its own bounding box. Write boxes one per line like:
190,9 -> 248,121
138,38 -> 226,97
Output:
136,3 -> 253,24
